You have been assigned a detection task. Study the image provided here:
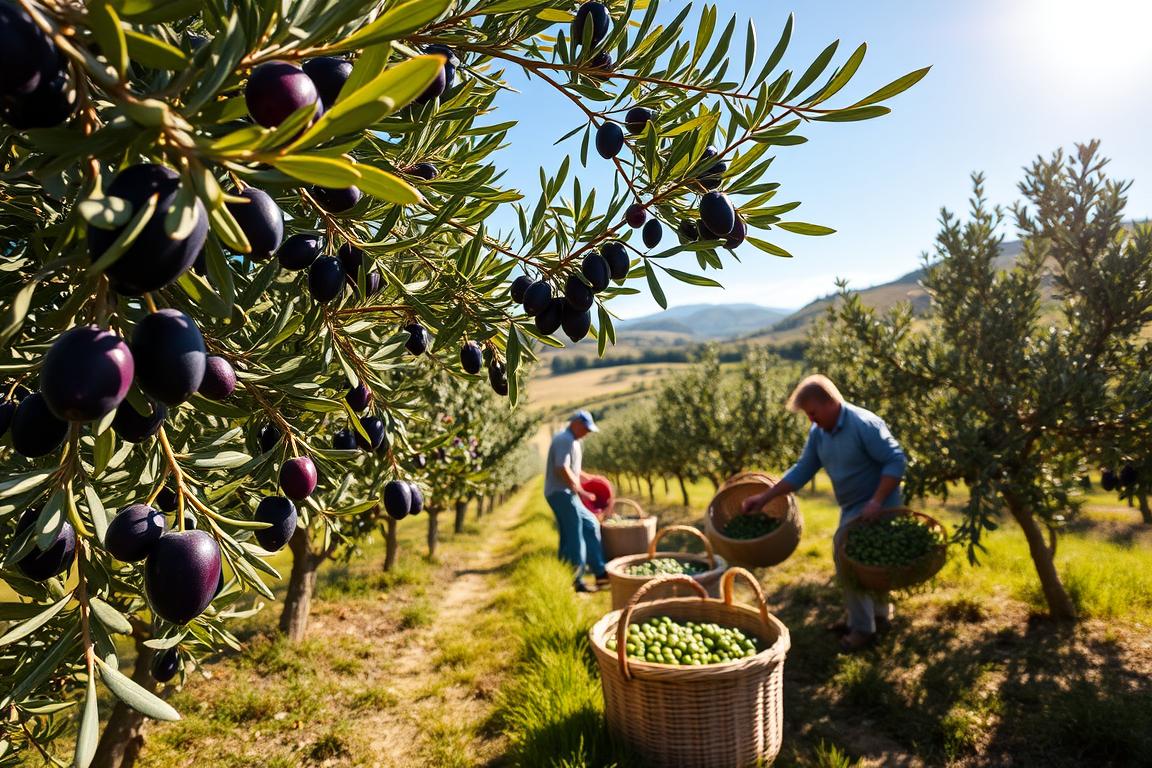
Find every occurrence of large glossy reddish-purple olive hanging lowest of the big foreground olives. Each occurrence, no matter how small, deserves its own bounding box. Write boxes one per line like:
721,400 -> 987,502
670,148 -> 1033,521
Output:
144,531 -> 221,624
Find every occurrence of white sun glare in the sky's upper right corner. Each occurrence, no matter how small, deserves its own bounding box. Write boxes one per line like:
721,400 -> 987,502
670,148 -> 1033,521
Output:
1005,0 -> 1152,90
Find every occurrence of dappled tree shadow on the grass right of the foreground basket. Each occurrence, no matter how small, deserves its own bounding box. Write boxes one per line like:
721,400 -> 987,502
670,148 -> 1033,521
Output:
770,573 -> 1152,768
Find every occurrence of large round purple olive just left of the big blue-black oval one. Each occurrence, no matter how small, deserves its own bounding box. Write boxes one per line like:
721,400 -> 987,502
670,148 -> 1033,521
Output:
40,326 -> 135,421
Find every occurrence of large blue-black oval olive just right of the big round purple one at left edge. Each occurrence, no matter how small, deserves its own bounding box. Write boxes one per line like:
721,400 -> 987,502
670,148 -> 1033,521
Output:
132,310 -> 207,405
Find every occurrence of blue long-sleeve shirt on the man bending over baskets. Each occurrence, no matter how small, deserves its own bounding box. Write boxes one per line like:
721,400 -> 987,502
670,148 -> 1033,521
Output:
783,403 -> 908,516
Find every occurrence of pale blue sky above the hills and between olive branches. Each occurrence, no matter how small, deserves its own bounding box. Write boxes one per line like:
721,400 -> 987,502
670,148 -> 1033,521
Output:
483,0 -> 1152,318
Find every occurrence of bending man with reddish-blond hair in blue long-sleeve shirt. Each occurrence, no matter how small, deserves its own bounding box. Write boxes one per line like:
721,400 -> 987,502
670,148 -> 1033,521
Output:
743,375 -> 907,652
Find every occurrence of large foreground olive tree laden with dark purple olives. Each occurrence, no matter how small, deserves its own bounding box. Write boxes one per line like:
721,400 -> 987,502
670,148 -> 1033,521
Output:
0,0 -> 924,767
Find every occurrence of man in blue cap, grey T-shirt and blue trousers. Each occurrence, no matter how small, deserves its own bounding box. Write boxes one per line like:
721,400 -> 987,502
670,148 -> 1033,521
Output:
544,411 -> 608,592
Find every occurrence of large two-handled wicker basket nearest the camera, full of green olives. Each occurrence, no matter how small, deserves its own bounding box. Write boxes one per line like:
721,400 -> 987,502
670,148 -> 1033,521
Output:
589,568 -> 790,768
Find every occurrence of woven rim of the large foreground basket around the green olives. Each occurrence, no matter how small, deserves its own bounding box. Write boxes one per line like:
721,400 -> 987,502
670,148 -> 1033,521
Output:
589,596 -> 791,682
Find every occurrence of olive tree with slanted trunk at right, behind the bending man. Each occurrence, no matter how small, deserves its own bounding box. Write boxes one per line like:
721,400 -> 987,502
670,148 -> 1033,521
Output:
810,143 -> 1152,619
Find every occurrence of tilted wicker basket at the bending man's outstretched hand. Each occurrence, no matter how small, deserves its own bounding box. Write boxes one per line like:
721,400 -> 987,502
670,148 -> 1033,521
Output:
704,472 -> 804,568
